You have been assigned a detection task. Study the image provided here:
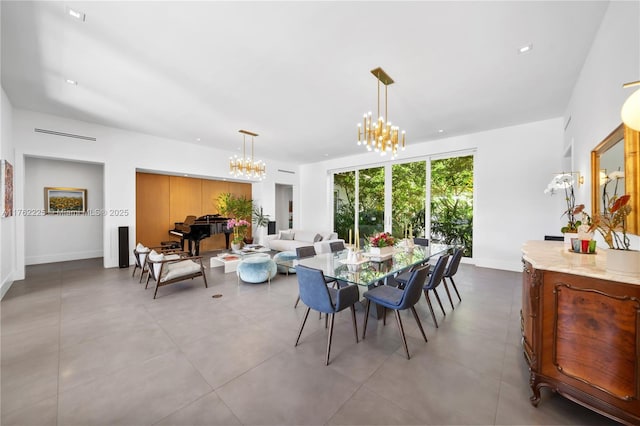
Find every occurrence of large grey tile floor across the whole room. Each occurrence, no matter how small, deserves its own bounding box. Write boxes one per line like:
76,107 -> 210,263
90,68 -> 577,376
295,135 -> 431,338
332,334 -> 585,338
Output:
0,255 -> 615,426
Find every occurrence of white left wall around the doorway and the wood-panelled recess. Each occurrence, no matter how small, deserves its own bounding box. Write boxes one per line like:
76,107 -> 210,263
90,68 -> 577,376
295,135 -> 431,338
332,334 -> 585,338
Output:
13,109 -> 297,279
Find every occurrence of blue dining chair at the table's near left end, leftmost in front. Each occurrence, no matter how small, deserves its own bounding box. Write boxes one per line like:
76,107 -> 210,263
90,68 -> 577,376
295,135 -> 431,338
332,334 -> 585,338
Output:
295,265 -> 360,365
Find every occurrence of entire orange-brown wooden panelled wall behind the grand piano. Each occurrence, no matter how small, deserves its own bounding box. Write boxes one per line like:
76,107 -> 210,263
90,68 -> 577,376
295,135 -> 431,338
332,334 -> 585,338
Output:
134,173 -> 251,253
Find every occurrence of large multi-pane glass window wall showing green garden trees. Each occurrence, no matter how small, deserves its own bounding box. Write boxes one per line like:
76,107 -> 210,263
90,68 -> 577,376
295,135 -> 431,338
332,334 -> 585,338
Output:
333,155 -> 473,257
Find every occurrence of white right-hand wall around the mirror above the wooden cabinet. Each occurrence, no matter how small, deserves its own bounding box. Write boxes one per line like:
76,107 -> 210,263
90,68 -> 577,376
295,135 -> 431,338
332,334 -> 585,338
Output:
564,1 -> 640,249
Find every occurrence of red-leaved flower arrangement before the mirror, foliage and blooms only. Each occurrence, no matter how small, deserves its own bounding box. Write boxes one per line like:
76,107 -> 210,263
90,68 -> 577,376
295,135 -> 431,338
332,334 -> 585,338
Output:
590,171 -> 631,250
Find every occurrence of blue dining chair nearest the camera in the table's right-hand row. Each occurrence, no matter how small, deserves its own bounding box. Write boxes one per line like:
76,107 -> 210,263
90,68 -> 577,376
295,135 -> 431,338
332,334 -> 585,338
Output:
362,266 -> 429,359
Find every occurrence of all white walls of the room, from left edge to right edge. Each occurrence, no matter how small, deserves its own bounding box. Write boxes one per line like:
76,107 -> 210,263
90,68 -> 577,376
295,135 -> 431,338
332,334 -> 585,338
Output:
5,2 -> 640,282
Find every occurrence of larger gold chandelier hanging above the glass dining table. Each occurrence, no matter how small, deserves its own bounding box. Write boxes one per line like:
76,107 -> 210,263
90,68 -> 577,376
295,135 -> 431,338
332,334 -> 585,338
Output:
358,68 -> 405,158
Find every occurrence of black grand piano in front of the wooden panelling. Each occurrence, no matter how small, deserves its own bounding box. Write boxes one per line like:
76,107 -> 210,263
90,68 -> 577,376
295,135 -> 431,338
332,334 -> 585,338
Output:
169,214 -> 233,256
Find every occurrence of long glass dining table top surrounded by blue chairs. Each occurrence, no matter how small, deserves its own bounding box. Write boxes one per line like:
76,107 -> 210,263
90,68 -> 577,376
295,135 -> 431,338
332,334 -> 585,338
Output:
275,244 -> 453,288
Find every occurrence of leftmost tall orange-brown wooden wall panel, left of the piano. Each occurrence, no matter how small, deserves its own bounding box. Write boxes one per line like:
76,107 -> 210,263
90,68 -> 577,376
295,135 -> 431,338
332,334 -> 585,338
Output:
134,173 -> 170,246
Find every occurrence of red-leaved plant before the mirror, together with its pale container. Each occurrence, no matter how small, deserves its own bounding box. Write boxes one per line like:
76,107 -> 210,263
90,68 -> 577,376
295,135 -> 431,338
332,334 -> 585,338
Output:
590,171 -> 640,275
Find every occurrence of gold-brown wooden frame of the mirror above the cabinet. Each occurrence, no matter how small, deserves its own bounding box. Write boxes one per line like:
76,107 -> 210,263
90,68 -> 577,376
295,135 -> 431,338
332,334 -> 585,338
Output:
591,124 -> 640,235
